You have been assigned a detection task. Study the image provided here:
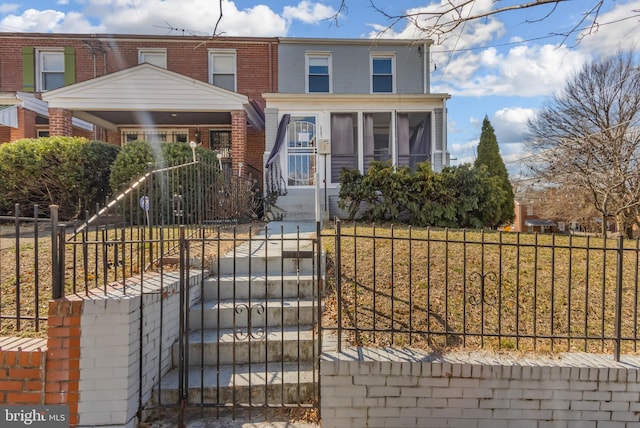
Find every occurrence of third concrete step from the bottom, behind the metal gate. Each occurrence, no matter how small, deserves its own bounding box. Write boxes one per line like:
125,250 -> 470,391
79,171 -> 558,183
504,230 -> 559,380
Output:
189,298 -> 318,330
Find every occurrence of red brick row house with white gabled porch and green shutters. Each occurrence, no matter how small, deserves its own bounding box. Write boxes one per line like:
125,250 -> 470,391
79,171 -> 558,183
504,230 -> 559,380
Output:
0,33 -> 278,171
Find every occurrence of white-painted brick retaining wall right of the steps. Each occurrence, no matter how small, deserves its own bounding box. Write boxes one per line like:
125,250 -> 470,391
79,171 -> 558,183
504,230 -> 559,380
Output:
320,347 -> 640,428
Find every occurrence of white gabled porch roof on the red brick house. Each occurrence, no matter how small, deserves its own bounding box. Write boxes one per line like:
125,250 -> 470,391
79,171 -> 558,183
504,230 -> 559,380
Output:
42,63 -> 264,130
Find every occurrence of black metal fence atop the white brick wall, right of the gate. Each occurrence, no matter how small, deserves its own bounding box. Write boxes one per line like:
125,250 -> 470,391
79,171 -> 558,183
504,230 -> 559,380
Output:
323,222 -> 640,360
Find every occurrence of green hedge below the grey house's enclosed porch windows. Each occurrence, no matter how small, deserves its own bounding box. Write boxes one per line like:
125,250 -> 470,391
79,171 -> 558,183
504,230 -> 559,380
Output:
338,162 -> 508,228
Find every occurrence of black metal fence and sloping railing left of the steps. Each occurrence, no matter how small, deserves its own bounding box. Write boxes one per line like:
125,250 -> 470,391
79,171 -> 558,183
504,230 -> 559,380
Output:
0,155 -> 262,335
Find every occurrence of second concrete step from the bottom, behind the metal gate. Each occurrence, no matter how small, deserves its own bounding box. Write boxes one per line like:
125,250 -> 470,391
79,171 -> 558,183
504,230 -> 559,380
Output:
172,326 -> 318,366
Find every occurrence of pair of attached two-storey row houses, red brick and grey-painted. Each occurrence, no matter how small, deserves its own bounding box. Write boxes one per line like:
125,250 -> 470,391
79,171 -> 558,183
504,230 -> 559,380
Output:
0,33 -> 449,219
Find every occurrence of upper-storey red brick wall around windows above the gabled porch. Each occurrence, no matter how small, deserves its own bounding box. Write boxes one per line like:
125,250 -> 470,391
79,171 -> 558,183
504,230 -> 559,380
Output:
0,33 -> 278,106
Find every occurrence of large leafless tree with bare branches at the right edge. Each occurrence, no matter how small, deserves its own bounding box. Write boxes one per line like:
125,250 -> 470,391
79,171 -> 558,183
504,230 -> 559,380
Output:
528,51 -> 640,237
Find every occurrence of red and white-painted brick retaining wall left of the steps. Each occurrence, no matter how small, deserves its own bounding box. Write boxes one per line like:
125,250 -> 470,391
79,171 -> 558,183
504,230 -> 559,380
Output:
0,271 -> 202,428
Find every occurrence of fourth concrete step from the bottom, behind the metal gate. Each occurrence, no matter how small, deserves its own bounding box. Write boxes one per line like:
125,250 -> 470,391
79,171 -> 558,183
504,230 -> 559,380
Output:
203,274 -> 318,300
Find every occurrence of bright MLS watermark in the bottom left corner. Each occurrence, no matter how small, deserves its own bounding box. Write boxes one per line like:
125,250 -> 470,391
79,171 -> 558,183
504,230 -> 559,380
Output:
0,406 -> 69,428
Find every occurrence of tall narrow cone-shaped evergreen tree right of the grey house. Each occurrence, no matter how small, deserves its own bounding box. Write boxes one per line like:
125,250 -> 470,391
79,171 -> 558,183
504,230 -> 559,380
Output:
474,116 -> 515,227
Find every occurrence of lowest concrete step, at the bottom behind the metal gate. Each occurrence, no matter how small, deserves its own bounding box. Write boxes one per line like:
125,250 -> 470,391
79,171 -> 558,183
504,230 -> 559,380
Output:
154,362 -> 318,406
